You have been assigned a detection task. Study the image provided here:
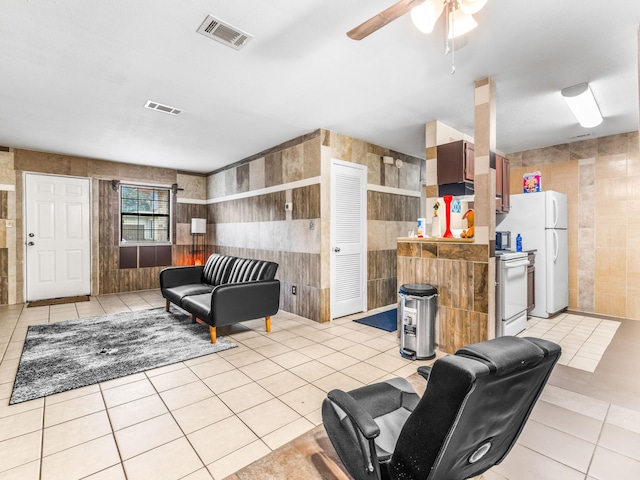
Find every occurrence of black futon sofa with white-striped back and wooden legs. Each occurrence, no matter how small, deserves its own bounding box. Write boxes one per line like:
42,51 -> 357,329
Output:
160,254 -> 280,343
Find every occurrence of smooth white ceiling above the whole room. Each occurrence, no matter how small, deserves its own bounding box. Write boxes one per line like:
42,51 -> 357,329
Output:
0,0 -> 640,173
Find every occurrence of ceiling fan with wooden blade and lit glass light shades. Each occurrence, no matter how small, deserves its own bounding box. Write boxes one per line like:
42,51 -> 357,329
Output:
347,0 -> 487,40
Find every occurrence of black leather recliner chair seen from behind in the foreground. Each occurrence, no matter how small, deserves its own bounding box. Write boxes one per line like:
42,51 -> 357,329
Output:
322,337 -> 561,480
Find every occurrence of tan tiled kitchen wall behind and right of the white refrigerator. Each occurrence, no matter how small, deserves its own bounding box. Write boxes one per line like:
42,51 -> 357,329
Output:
507,132 -> 640,319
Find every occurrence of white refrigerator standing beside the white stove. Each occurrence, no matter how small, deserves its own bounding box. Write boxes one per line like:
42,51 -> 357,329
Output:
496,191 -> 569,318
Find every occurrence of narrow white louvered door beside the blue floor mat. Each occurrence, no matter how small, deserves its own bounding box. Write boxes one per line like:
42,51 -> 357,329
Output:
331,160 -> 367,318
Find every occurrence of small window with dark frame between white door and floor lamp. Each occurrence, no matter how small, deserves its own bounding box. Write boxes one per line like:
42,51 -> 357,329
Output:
120,185 -> 171,243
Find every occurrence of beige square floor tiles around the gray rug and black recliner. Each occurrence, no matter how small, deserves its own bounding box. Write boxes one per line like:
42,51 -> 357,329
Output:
0,291 -> 640,480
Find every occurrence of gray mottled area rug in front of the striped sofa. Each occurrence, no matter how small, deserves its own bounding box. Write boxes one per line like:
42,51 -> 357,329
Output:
9,308 -> 237,405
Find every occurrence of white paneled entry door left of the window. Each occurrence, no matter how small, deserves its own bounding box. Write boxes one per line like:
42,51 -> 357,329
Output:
24,173 -> 91,301
